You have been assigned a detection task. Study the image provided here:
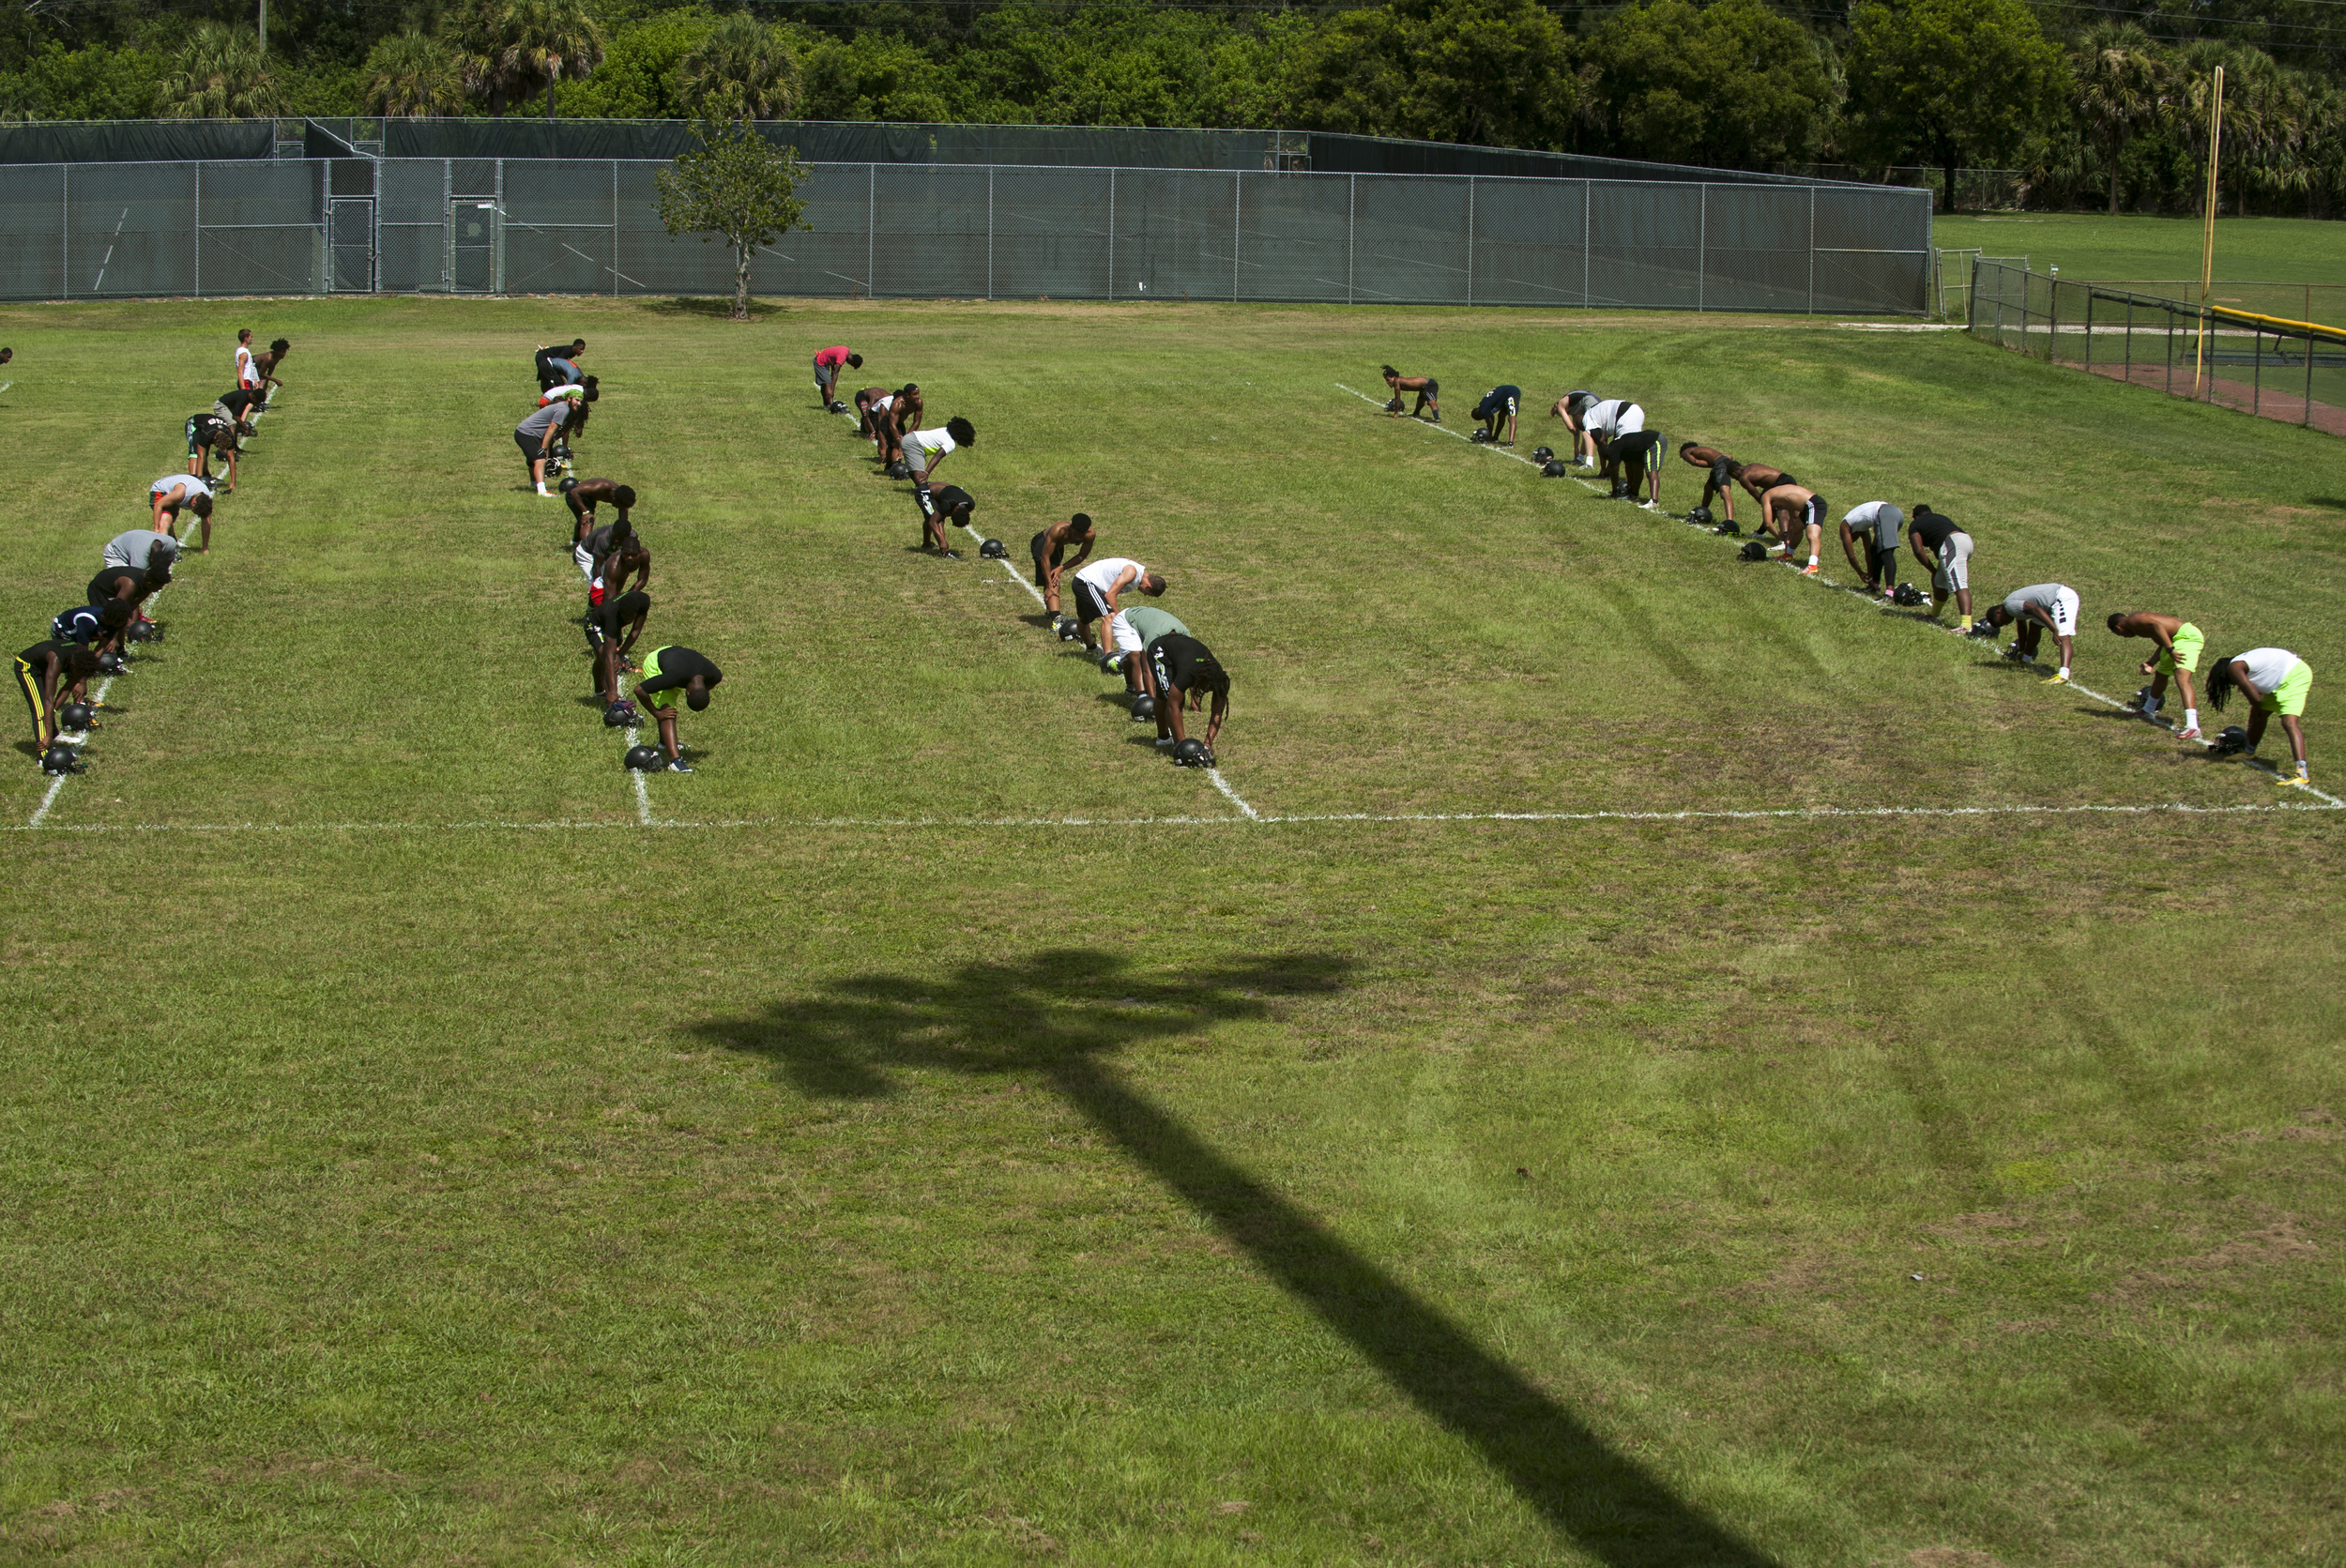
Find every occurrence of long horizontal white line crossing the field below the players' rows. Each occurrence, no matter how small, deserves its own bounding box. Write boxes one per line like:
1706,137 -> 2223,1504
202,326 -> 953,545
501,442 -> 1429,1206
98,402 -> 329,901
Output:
8,800 -> 2339,833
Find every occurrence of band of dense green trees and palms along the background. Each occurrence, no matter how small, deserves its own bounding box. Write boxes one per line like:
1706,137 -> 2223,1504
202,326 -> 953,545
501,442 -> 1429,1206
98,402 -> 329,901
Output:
0,0 -> 2346,216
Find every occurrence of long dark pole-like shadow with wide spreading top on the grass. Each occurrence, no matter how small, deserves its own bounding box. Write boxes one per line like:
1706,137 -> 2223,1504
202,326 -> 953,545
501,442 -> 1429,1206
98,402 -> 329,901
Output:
694,949 -> 1774,1568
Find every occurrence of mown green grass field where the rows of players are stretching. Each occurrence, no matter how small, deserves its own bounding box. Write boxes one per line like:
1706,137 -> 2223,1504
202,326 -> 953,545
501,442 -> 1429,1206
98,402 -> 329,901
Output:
0,291 -> 2346,1568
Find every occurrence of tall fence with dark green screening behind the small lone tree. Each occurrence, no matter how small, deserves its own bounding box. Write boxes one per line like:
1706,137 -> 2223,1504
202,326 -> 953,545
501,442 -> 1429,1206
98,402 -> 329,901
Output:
0,158 -> 1931,314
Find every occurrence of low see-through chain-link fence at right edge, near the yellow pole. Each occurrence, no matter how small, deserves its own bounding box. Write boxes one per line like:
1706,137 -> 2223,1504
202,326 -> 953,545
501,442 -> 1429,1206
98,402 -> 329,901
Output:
1969,261 -> 2346,434
